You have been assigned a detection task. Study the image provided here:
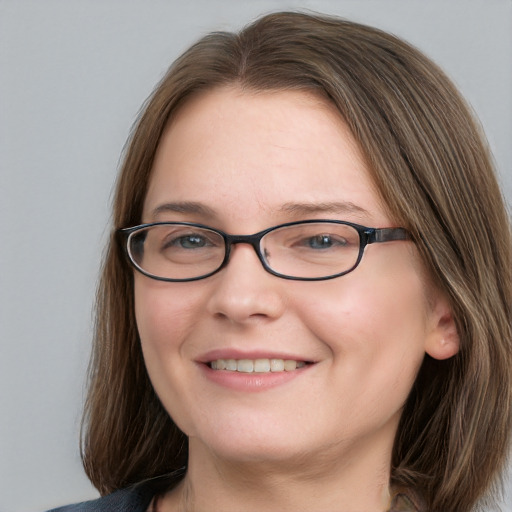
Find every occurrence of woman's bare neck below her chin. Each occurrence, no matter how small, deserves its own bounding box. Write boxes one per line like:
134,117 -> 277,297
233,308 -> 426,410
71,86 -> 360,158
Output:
162,432 -> 391,512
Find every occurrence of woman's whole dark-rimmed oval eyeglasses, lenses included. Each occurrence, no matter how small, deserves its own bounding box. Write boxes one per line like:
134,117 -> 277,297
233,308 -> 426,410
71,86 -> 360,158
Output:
119,220 -> 411,281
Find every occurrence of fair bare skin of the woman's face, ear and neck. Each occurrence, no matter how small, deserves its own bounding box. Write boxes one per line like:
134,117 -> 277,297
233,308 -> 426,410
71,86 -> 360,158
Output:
135,87 -> 458,512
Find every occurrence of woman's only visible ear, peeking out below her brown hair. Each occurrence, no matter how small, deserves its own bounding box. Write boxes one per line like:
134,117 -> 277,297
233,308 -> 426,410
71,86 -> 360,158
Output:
425,294 -> 460,359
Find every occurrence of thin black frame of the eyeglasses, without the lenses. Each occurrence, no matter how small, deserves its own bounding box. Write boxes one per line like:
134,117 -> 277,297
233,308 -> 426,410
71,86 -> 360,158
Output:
117,219 -> 412,283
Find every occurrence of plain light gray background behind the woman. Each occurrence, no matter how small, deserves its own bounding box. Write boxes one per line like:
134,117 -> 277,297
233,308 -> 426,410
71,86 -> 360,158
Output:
0,0 -> 512,512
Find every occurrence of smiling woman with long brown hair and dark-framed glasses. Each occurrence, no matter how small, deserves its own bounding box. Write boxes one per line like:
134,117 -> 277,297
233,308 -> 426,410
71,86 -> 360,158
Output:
50,9 -> 512,512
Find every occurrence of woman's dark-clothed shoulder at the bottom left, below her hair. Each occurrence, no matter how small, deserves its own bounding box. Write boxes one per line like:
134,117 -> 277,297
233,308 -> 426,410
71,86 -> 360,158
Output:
48,485 -> 155,512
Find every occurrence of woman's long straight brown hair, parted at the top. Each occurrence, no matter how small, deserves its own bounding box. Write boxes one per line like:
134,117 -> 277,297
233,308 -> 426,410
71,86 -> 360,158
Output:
83,13 -> 512,511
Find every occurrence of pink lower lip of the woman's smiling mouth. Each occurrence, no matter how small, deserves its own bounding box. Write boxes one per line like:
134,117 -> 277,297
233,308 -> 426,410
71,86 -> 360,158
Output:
200,364 -> 313,392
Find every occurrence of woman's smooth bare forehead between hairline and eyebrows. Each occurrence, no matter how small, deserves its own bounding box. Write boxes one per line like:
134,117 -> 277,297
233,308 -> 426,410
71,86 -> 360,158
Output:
144,87 -> 385,227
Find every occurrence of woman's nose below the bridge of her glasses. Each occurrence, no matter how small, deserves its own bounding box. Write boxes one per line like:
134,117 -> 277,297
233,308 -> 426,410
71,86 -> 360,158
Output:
207,243 -> 286,324
